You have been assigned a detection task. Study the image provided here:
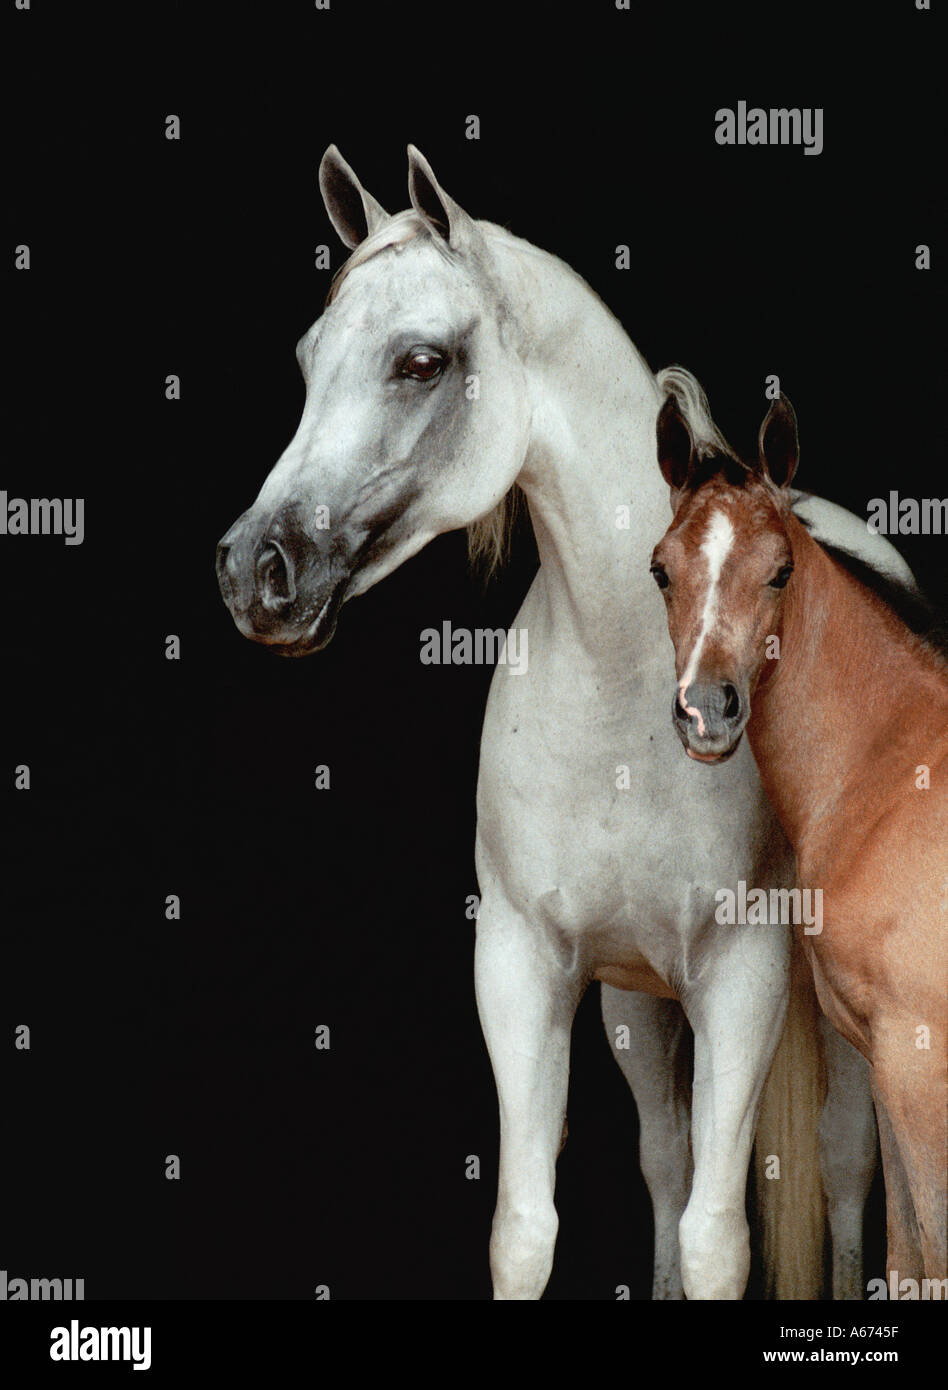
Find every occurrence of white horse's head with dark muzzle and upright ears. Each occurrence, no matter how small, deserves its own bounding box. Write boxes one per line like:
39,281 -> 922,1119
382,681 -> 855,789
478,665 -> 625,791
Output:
217,146 -> 531,656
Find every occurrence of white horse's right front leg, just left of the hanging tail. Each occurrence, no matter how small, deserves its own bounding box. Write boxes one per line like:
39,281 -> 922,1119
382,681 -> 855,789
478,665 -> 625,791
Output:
678,927 -> 788,1300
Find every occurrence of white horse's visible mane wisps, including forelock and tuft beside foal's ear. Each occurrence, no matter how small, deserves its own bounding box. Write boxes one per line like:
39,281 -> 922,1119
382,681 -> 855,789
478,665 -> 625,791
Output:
325,207 -> 735,578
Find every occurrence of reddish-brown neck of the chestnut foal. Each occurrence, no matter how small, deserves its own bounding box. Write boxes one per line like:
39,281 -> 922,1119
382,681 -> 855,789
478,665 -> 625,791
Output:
748,516 -> 948,863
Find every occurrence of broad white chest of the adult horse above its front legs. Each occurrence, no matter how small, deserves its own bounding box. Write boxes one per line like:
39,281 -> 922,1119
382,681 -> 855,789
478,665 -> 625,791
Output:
478,619 -> 787,992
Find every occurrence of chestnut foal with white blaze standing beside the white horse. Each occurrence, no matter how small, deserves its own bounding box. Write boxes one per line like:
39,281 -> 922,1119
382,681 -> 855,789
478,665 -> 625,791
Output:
652,396 -> 948,1278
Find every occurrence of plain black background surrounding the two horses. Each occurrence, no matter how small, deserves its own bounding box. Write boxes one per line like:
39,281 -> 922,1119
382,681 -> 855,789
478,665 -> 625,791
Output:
0,0 -> 948,1300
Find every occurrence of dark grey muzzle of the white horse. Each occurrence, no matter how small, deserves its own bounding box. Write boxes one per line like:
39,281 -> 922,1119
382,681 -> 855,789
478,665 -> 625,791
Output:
217,507 -> 349,656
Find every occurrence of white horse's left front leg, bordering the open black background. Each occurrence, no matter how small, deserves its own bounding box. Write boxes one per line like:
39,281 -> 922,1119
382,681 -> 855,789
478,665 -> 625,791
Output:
474,899 -> 585,1298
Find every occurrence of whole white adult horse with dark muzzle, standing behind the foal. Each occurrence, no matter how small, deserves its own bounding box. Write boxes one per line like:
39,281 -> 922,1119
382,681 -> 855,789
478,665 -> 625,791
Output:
212,147 -> 884,1298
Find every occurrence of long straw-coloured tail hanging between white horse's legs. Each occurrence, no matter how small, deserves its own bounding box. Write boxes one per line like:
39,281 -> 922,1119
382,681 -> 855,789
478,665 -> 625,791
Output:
753,937 -> 826,1298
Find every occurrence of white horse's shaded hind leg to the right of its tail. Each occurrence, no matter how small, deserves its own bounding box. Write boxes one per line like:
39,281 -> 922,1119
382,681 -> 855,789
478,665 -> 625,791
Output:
820,1015 -> 876,1300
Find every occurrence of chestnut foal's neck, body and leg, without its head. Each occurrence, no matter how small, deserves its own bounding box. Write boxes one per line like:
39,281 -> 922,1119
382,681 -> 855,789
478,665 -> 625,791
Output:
748,514 -> 948,1279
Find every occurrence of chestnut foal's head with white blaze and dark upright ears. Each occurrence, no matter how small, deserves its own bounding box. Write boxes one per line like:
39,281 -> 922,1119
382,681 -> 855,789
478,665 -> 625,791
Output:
652,396 -> 798,763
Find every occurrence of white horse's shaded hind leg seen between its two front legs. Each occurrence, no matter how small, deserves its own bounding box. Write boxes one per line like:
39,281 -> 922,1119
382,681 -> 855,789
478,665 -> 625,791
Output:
602,984 -> 691,1298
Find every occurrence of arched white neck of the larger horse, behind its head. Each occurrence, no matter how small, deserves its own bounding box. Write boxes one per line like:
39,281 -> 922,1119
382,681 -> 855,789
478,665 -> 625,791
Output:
492,234 -> 670,660
